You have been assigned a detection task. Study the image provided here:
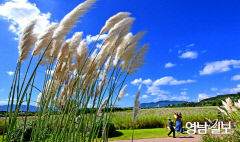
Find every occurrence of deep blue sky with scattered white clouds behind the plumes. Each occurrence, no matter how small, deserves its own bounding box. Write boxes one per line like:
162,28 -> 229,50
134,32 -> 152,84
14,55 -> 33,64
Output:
0,0 -> 240,106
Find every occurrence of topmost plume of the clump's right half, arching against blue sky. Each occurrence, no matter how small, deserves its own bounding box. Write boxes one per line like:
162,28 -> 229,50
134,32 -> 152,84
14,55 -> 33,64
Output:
100,12 -> 131,34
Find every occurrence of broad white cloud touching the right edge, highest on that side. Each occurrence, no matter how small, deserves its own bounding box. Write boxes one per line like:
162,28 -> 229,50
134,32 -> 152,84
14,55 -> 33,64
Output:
200,60 -> 240,75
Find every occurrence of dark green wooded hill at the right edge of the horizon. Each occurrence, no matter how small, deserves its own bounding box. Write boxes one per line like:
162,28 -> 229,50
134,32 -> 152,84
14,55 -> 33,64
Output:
177,93 -> 240,107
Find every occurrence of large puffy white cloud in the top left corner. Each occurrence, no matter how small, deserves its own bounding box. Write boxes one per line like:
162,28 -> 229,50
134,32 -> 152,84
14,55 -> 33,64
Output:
0,0 -> 51,36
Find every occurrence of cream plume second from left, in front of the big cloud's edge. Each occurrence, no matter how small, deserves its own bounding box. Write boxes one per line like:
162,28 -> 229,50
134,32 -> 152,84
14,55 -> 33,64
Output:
32,23 -> 58,56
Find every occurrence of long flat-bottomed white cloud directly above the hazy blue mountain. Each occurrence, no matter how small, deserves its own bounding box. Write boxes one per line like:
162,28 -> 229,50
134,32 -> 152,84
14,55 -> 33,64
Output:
153,76 -> 195,86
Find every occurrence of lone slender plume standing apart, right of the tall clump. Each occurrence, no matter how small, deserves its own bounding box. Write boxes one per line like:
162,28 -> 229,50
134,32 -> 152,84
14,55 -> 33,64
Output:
133,84 -> 142,123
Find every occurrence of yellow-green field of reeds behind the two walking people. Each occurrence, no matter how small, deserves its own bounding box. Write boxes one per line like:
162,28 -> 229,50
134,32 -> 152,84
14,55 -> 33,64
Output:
111,107 -> 218,129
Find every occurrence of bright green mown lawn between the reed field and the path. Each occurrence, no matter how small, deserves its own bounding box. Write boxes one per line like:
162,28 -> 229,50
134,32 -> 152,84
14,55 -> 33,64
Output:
108,128 -> 188,141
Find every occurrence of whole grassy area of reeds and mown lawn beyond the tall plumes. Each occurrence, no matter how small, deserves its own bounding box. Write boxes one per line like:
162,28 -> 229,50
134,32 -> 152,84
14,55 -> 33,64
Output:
0,107 -> 217,141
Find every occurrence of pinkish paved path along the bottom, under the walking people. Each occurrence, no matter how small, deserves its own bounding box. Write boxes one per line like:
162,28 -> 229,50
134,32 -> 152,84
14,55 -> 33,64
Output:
111,135 -> 202,142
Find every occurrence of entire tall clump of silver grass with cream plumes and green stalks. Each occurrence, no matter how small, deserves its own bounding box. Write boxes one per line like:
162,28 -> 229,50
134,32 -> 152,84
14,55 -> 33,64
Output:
3,0 -> 146,142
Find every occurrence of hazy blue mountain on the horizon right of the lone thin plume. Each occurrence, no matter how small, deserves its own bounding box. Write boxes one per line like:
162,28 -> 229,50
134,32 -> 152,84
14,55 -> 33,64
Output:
140,100 -> 185,108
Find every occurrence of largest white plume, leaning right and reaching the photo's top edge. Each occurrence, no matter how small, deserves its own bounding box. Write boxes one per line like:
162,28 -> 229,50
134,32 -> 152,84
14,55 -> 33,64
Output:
53,0 -> 96,40
